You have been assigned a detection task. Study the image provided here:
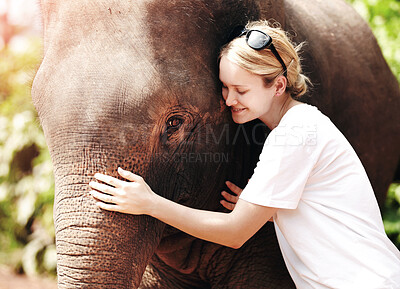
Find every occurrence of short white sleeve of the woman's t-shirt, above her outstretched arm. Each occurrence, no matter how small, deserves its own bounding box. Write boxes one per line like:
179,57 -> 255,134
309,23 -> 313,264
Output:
240,122 -> 316,209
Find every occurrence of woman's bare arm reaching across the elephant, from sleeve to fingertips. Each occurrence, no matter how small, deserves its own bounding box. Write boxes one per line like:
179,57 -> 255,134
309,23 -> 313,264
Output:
89,169 -> 277,248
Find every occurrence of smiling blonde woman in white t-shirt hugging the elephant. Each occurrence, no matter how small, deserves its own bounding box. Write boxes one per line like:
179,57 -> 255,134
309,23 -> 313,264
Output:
90,21 -> 400,289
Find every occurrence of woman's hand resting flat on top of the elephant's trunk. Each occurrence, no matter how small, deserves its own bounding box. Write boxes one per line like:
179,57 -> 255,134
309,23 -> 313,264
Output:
89,168 -> 157,215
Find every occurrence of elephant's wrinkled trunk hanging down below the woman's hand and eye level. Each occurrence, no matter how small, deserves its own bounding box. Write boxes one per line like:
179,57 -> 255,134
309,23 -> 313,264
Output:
52,146 -> 164,288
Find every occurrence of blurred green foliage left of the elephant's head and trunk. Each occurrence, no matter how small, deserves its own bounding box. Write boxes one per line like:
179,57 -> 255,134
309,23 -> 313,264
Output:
0,39 -> 56,274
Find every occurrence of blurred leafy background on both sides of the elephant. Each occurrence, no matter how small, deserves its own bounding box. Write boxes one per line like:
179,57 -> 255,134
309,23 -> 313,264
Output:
0,0 -> 400,289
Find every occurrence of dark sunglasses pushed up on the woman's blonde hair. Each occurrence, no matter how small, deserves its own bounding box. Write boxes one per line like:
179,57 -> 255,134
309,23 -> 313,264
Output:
227,25 -> 287,77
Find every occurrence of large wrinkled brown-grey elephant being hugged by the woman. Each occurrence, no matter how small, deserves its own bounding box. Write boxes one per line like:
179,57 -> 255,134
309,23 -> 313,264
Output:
32,0 -> 400,288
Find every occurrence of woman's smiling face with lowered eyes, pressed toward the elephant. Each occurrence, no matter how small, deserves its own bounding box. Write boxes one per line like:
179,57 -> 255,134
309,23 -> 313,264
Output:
219,56 -> 275,123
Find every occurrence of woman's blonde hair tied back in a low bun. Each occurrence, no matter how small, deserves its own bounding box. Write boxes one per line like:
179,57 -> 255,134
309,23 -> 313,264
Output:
219,20 -> 311,98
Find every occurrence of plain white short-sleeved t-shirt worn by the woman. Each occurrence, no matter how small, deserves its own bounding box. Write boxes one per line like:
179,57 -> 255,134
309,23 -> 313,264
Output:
240,104 -> 400,289
